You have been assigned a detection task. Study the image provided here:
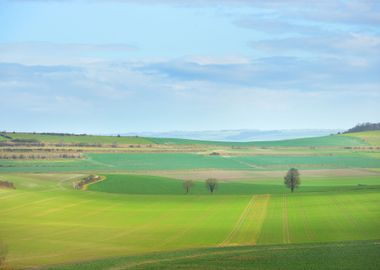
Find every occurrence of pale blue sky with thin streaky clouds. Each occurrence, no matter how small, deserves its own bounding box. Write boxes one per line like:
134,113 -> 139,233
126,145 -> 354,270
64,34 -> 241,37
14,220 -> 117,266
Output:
0,0 -> 380,134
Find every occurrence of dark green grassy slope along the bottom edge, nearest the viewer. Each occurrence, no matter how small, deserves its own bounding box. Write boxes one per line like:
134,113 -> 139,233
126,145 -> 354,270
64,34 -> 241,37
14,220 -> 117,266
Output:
49,241 -> 380,270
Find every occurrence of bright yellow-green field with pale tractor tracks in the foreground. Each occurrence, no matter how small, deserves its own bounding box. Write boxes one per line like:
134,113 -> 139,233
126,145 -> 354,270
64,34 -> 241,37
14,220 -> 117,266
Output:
0,174 -> 380,269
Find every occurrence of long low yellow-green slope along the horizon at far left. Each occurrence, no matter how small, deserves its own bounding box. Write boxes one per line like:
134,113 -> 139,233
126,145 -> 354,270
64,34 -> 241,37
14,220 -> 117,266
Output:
6,133 -> 152,144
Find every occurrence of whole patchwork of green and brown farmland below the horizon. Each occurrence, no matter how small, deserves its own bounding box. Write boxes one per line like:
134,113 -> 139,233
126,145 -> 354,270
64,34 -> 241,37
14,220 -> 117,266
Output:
0,133 -> 380,269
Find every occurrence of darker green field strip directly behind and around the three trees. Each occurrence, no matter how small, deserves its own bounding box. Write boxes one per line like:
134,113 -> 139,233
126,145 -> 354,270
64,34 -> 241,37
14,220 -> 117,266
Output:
88,172 -> 380,196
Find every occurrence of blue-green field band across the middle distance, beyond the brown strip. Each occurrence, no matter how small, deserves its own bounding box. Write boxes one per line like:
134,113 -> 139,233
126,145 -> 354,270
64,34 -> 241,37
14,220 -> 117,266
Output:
0,151 -> 380,172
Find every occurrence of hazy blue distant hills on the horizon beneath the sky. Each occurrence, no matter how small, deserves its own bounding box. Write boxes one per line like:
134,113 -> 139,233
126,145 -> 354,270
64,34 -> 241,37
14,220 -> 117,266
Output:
120,129 -> 342,142
